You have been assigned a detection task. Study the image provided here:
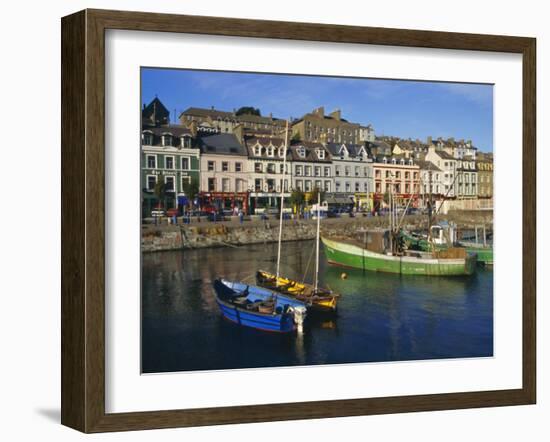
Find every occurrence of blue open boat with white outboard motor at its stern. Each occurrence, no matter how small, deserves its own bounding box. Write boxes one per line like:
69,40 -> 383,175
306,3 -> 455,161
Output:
213,279 -> 306,333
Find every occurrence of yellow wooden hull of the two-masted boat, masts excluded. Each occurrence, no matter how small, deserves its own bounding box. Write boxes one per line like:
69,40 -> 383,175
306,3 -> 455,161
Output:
256,270 -> 340,311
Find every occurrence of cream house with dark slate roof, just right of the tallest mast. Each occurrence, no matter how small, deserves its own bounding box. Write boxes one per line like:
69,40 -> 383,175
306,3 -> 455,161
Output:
290,141 -> 334,193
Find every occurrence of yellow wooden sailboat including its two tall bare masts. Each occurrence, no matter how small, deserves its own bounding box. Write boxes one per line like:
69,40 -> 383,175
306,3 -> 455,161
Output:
256,122 -> 339,311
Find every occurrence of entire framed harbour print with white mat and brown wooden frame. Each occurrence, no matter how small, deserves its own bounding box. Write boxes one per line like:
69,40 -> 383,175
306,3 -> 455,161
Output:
62,10 -> 536,432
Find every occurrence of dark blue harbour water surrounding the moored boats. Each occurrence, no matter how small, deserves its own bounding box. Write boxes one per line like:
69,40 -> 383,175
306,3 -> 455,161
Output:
142,241 -> 493,373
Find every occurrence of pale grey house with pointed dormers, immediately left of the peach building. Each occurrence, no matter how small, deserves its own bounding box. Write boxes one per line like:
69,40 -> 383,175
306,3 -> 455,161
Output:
326,143 -> 374,210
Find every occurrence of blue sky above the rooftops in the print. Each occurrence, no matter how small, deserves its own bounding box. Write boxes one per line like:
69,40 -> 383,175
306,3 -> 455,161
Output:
141,68 -> 493,151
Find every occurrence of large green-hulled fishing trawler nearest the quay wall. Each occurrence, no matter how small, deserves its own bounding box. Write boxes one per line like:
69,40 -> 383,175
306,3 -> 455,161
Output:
321,230 -> 477,276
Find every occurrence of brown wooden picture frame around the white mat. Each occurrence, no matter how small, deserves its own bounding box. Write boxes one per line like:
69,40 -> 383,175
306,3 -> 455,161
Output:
61,10 -> 536,432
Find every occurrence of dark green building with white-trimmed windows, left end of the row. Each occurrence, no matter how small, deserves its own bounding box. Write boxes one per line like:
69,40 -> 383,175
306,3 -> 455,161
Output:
140,98 -> 200,218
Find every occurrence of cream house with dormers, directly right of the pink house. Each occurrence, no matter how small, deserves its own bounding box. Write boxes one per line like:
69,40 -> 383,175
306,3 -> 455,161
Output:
244,136 -> 292,212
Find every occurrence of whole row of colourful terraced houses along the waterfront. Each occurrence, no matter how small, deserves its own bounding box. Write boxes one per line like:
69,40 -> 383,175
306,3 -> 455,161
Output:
141,98 -> 492,216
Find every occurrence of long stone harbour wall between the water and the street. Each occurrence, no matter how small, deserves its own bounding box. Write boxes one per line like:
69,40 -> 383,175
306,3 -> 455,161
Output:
141,211 -> 493,253
